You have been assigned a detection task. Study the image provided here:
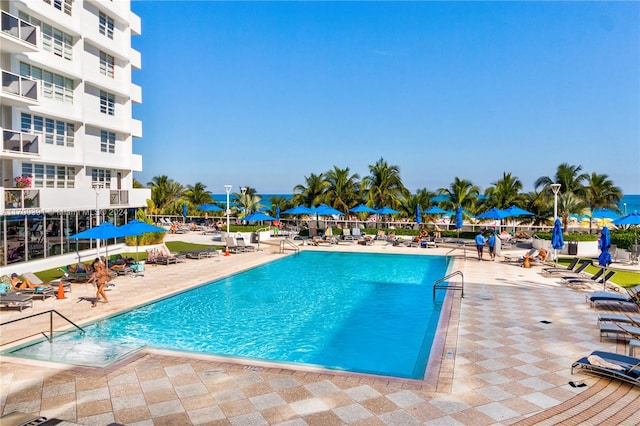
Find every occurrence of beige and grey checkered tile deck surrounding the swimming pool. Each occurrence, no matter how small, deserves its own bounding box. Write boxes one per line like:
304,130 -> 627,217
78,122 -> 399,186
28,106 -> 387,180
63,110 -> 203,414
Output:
0,241 -> 640,425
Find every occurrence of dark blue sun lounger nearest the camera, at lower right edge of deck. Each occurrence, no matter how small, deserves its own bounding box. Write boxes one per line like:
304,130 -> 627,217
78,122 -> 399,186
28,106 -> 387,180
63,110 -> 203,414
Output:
571,351 -> 640,386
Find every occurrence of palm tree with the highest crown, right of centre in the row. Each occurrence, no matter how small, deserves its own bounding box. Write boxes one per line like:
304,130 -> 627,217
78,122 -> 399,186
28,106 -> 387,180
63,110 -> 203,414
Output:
362,158 -> 410,209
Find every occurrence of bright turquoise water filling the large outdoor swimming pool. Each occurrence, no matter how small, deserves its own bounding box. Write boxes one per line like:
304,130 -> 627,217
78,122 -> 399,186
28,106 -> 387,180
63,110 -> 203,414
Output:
7,252 -> 447,379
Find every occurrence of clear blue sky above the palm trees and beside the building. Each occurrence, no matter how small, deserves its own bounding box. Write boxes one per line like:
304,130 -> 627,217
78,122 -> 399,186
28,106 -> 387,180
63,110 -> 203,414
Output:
132,0 -> 640,194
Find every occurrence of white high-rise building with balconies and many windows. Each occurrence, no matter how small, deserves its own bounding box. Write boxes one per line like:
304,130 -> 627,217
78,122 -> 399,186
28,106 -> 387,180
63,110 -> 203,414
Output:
0,0 -> 150,274
